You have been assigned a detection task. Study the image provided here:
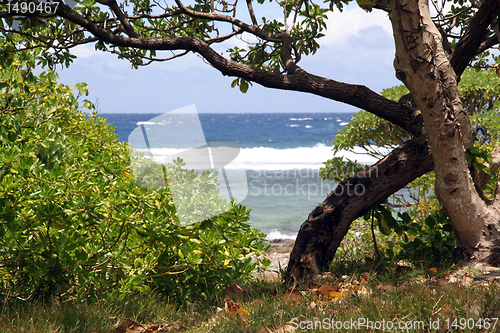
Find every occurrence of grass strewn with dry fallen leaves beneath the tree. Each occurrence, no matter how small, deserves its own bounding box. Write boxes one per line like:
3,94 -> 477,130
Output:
0,260 -> 500,333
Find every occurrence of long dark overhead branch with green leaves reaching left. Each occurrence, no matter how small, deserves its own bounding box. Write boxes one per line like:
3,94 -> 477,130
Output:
0,0 -> 498,135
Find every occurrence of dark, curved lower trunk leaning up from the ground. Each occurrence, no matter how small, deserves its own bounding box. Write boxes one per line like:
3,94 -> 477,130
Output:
285,136 -> 433,282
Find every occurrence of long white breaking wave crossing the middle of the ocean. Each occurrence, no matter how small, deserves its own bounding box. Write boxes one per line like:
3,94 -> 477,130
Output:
137,144 -> 377,171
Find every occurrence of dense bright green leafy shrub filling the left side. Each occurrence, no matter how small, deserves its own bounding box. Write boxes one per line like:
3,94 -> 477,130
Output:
0,40 -> 266,302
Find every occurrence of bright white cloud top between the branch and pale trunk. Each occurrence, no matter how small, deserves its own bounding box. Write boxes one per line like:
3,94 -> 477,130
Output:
319,5 -> 392,45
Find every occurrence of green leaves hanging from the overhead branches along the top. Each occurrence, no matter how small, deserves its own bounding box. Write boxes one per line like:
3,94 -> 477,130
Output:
0,0 -> 498,76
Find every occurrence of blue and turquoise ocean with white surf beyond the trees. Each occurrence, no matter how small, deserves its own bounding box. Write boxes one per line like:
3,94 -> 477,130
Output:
100,113 -> 375,239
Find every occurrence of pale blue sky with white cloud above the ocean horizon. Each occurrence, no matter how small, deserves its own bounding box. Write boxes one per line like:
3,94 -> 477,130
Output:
52,2 -> 401,113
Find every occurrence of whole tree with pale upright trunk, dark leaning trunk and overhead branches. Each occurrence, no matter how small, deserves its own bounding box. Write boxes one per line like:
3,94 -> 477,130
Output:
0,0 -> 500,280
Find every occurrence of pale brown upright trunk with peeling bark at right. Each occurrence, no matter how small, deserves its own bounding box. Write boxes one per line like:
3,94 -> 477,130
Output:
389,0 -> 500,265
